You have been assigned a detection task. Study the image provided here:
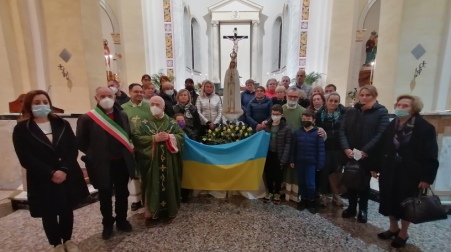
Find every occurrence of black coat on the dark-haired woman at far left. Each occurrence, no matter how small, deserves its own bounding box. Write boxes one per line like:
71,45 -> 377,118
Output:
13,116 -> 89,217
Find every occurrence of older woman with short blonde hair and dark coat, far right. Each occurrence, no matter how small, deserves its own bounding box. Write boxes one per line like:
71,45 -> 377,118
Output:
371,95 -> 439,248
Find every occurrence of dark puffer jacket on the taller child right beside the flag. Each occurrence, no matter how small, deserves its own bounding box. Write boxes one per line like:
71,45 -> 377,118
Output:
265,117 -> 293,164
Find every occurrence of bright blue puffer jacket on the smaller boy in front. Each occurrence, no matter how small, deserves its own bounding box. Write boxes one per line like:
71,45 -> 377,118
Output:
290,127 -> 326,170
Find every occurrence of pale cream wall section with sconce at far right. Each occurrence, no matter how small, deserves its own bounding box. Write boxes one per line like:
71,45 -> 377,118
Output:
394,0 -> 449,111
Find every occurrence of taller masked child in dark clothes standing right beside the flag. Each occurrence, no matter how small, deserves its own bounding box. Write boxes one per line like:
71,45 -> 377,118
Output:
263,104 -> 292,205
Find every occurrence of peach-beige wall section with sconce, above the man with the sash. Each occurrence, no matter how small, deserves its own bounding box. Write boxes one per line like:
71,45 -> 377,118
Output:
40,0 -> 106,113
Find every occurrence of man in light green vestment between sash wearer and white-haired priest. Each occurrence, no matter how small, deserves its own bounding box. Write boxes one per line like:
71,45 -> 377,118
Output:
121,83 -> 150,211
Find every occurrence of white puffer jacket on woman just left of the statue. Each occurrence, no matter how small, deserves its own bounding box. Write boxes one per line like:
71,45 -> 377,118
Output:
196,93 -> 222,125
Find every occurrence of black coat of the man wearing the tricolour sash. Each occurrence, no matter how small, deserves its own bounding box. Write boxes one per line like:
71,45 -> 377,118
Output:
77,107 -> 137,189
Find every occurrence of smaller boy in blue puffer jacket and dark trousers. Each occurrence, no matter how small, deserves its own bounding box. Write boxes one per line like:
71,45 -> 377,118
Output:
290,110 -> 325,214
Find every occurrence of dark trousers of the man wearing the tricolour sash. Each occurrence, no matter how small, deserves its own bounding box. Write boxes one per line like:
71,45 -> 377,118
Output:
99,158 -> 129,226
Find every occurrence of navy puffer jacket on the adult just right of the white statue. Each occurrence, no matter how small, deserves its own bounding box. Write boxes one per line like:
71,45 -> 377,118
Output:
246,96 -> 272,129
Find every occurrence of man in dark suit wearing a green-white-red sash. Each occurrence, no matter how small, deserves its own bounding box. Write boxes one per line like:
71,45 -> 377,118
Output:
77,87 -> 136,240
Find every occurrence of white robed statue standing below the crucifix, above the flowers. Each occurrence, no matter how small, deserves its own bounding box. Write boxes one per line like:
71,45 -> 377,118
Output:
222,50 -> 243,121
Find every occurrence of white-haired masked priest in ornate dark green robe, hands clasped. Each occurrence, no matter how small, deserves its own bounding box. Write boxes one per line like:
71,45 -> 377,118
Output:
133,96 -> 184,220
